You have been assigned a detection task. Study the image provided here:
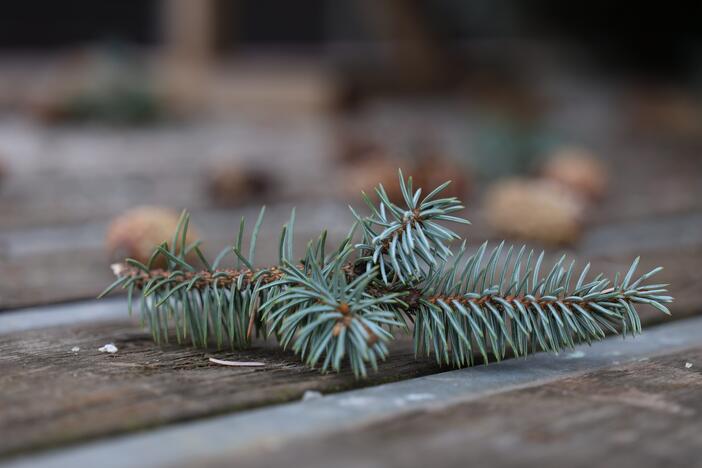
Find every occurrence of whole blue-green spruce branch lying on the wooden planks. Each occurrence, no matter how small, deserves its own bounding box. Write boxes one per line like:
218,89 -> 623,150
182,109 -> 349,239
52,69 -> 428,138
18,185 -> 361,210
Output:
103,172 -> 673,376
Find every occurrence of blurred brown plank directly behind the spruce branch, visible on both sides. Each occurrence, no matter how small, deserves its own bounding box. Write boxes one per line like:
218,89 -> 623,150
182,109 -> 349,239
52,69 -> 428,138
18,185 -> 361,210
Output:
0,207 -> 702,311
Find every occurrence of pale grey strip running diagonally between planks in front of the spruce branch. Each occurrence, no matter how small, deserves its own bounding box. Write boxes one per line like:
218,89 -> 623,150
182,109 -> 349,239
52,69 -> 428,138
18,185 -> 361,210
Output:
6,314 -> 702,468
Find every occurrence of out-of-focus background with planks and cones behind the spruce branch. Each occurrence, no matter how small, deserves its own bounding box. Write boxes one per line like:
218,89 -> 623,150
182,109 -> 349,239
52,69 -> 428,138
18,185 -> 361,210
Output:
0,0 -> 702,309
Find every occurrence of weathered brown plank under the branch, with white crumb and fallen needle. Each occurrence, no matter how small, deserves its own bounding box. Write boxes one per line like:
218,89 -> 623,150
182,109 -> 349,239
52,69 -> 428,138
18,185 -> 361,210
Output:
0,321 -> 439,457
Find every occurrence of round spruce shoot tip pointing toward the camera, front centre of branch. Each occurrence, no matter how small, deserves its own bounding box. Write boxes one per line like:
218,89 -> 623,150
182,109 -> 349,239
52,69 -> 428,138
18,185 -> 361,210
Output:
262,263 -> 403,376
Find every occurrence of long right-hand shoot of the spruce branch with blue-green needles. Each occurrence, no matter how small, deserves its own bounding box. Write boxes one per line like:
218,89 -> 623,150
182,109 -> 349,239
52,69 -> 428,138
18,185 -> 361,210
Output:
414,243 -> 673,367
